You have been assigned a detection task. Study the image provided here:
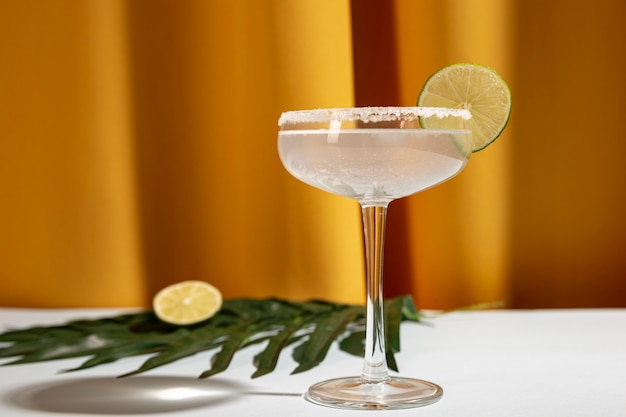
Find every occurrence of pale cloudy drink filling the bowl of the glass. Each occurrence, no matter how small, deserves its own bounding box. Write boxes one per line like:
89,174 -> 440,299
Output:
278,128 -> 470,205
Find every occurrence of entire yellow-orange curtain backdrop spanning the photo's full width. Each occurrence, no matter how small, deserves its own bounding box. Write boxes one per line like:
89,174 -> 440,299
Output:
0,0 -> 626,308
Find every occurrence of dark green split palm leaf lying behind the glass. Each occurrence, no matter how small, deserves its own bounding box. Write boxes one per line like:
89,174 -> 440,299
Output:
0,296 -> 421,378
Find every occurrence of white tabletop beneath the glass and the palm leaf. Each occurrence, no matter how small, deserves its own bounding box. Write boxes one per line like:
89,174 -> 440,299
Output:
0,308 -> 626,417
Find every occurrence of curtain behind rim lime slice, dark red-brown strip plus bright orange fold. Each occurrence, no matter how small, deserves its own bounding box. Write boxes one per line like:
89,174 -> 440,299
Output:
352,0 -> 513,309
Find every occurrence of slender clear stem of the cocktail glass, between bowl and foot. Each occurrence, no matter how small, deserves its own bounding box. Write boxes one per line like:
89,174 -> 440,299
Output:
361,206 -> 389,382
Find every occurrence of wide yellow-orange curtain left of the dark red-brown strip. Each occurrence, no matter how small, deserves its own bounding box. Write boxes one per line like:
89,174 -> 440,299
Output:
0,0 -> 364,306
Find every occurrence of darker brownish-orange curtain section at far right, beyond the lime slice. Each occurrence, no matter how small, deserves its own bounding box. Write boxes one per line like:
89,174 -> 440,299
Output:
510,0 -> 626,308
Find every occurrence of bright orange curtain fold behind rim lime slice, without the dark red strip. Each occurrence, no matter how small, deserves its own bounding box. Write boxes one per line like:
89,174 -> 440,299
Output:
395,0 -> 517,308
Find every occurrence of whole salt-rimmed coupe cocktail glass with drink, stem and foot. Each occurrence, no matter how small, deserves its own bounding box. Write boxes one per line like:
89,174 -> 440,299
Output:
278,107 -> 471,409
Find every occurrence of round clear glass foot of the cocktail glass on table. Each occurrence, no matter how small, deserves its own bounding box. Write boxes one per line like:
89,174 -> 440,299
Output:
304,376 -> 443,410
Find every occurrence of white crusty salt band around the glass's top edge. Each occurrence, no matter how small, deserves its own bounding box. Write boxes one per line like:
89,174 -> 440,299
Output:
278,107 -> 472,126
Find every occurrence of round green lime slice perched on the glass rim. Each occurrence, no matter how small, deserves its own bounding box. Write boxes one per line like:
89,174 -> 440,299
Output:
417,63 -> 511,152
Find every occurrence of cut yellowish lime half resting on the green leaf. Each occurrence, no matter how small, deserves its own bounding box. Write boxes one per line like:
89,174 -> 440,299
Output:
152,281 -> 222,325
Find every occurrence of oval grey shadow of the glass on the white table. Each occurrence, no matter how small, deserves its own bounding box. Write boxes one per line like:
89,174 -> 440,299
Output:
3,376 -> 300,414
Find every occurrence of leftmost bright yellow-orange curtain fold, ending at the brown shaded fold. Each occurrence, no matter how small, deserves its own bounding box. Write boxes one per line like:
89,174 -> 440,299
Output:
0,0 -> 145,306
